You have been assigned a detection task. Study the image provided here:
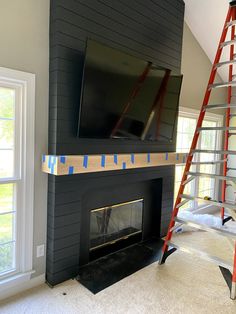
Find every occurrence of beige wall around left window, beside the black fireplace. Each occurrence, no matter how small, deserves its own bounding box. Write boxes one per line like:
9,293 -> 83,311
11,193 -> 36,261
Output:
0,0 -> 50,276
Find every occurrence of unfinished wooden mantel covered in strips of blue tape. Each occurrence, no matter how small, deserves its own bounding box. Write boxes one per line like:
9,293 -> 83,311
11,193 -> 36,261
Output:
42,153 -> 187,176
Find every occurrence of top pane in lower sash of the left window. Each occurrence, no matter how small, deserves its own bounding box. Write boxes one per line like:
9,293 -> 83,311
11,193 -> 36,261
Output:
0,184 -> 14,214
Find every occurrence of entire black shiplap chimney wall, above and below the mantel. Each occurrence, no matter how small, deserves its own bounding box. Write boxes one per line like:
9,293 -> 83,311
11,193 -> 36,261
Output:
47,0 -> 184,285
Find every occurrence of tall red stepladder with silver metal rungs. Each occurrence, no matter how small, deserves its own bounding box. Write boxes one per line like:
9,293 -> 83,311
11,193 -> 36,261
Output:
159,0 -> 236,299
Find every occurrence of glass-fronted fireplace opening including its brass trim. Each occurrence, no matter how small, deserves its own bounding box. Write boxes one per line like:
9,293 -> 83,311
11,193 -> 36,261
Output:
89,199 -> 144,259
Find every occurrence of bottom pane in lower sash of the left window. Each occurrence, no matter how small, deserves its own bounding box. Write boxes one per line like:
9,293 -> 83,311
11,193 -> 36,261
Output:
0,242 -> 15,273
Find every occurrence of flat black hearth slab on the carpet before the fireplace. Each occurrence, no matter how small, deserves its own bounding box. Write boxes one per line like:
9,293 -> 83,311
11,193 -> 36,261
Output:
76,239 -> 163,294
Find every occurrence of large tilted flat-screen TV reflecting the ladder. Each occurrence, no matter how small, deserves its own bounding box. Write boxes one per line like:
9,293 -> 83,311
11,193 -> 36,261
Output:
78,40 -> 182,142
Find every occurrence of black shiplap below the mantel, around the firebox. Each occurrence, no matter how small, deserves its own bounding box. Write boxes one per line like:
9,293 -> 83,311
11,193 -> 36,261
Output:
47,166 -> 174,285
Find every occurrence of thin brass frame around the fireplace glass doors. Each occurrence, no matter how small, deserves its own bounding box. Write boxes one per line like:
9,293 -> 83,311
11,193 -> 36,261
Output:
89,198 -> 144,252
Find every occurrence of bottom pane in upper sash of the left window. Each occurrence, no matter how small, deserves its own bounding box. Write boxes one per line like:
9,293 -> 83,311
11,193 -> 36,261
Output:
0,149 -> 14,178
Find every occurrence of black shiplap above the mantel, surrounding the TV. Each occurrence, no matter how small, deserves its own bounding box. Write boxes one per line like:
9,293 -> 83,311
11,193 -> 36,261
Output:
49,0 -> 184,154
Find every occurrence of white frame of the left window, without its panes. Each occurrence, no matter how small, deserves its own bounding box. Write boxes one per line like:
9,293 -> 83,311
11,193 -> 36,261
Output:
0,67 -> 35,291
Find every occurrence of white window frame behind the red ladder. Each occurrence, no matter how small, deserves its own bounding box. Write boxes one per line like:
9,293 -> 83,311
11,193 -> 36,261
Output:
178,107 -> 224,209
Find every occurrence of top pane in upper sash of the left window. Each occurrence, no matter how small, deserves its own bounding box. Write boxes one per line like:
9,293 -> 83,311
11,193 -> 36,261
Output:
0,87 -> 15,119
